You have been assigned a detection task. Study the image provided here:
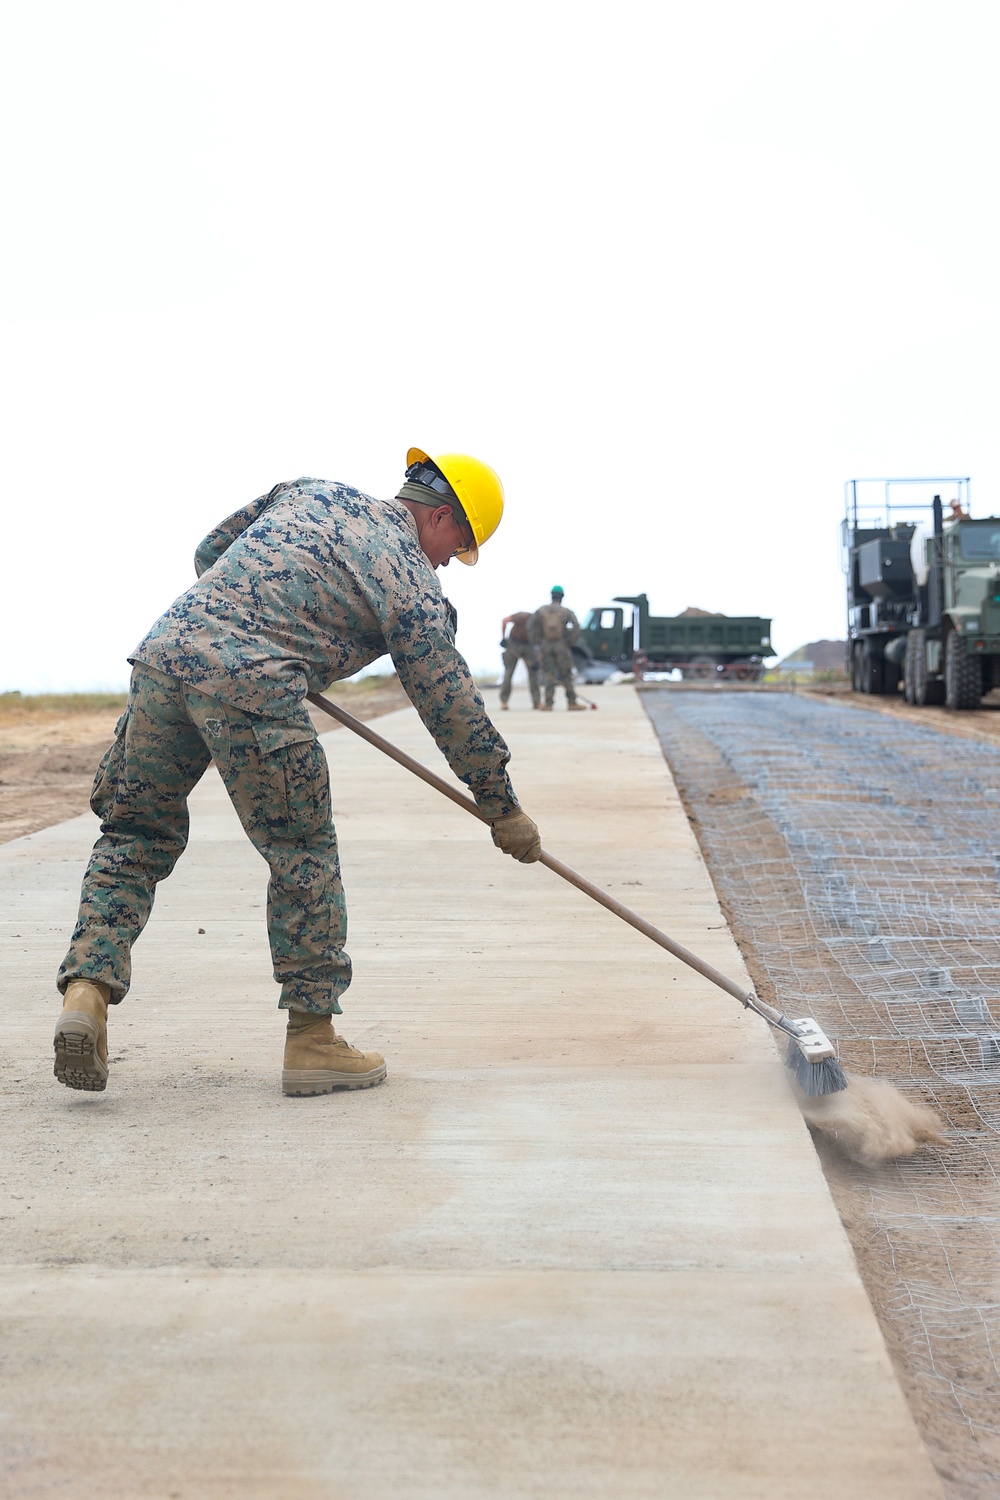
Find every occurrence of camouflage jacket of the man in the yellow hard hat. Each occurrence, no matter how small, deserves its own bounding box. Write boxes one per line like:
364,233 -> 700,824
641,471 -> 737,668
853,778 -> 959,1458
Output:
129,479 -> 517,818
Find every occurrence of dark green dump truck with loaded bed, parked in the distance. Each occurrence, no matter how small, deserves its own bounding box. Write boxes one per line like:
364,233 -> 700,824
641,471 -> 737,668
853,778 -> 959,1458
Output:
573,594 -> 772,683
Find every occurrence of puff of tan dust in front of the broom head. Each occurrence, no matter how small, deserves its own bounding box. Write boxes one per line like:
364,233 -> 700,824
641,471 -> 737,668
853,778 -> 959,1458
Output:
795,1073 -> 945,1167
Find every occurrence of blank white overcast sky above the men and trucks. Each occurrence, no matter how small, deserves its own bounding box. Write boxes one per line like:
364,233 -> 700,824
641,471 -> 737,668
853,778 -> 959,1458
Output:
0,0 -> 1000,692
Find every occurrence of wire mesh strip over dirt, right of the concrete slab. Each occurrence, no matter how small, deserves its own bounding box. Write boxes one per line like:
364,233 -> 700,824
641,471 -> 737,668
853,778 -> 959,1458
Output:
643,689 -> 1000,1500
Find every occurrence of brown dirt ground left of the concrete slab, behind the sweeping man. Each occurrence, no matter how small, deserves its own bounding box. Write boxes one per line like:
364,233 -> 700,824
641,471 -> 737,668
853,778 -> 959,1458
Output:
0,677 -> 409,843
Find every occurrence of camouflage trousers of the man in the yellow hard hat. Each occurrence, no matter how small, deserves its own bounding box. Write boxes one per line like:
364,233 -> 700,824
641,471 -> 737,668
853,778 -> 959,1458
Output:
57,666 -> 351,1016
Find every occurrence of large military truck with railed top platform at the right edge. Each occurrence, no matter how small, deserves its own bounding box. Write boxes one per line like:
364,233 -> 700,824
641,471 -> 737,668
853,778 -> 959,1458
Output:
841,477 -> 1000,710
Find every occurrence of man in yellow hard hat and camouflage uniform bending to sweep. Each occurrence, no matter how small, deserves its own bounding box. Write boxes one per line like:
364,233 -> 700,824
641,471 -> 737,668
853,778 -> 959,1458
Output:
54,449 -> 541,1095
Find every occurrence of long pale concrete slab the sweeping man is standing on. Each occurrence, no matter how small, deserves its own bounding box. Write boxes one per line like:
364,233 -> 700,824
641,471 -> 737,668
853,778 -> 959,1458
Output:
0,687 -> 940,1500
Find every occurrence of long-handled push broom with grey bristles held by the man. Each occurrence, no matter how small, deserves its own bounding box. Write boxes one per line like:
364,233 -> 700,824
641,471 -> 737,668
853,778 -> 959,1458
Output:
307,693 -> 847,1098
